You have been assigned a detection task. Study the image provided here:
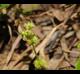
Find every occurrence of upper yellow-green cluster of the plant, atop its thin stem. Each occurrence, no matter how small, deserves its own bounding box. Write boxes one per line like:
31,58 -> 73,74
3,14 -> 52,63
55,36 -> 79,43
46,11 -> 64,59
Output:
20,21 -> 39,46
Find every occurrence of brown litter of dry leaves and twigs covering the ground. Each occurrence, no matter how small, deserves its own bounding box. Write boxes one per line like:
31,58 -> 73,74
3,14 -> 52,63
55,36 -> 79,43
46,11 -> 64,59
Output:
0,4 -> 80,70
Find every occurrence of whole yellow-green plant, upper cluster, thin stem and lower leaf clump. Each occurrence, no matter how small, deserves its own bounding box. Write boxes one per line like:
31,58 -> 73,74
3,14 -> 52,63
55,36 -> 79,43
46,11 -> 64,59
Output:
20,21 -> 47,69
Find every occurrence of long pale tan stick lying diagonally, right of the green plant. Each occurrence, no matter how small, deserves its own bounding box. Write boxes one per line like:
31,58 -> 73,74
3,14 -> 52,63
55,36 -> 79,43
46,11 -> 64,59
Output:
30,24 -> 63,58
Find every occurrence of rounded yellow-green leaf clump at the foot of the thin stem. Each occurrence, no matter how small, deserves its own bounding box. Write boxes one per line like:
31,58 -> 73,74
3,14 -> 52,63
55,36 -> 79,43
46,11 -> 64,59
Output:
34,58 -> 47,69
